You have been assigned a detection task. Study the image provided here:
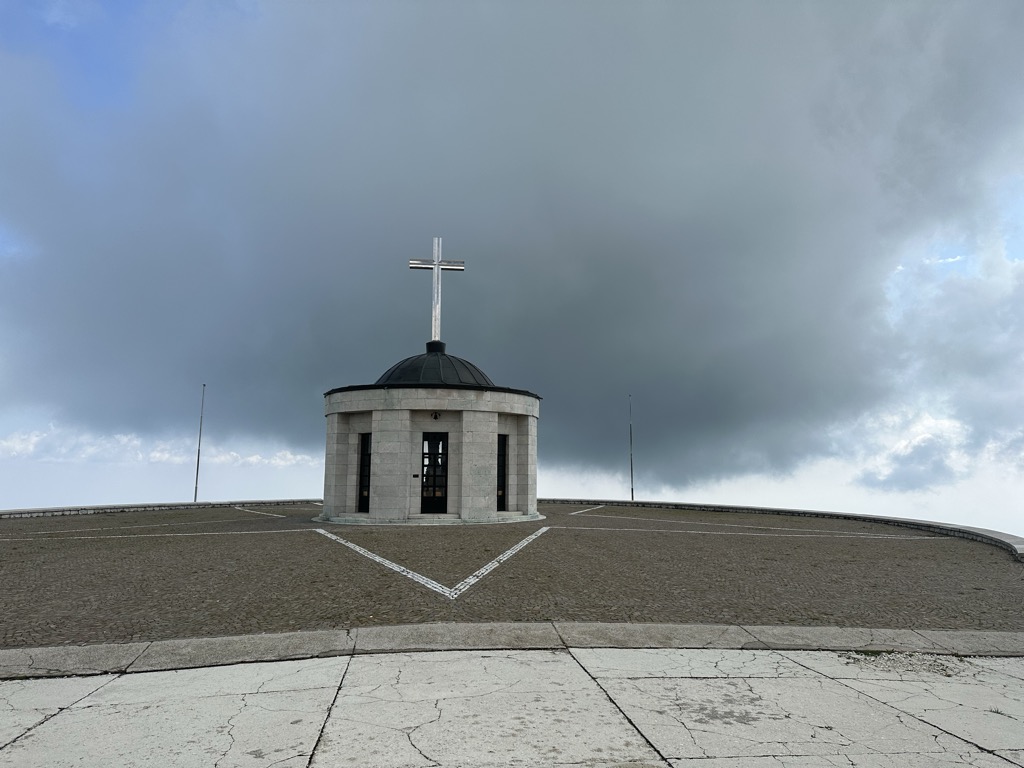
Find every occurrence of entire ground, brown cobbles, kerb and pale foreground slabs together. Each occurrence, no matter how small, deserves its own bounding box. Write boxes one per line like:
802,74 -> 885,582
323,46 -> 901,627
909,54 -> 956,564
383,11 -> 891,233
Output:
0,504 -> 1024,768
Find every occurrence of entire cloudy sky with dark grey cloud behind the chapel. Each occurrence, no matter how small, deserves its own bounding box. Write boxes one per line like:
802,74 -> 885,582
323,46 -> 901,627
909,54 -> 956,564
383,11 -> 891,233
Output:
0,0 -> 1024,535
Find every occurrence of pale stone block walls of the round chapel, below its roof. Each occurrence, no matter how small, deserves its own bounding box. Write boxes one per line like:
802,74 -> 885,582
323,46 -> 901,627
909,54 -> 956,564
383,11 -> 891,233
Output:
321,385 -> 540,524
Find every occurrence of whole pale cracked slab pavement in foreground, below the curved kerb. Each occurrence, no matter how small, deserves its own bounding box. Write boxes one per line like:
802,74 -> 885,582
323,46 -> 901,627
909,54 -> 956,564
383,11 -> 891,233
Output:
0,648 -> 1024,768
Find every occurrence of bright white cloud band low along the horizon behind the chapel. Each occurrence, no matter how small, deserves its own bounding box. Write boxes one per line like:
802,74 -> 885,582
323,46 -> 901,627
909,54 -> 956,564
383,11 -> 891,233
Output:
0,423 -> 1024,535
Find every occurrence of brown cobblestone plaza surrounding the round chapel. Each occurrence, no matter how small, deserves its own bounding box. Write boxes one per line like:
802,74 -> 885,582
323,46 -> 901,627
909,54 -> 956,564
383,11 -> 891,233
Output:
0,504 -> 1024,649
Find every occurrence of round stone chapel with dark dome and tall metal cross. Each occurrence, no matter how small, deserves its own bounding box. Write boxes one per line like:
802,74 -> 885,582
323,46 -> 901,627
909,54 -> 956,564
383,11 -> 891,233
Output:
318,238 -> 541,524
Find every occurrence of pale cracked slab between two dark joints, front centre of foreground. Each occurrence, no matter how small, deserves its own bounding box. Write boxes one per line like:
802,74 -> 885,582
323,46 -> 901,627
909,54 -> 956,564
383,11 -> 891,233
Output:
312,651 -> 657,766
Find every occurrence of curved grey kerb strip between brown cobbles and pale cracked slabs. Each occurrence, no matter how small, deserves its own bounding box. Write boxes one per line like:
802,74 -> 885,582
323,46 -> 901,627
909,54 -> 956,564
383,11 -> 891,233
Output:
0,622 -> 1024,680
